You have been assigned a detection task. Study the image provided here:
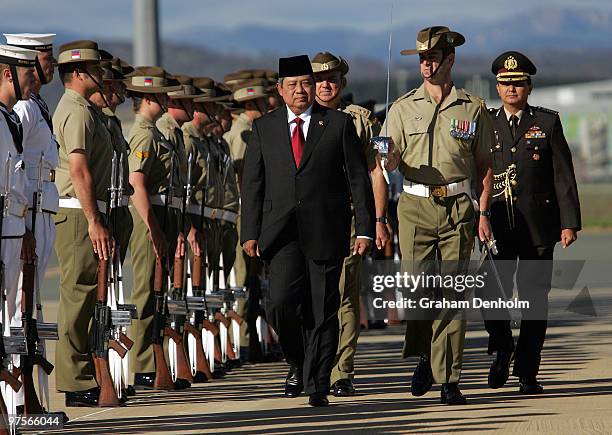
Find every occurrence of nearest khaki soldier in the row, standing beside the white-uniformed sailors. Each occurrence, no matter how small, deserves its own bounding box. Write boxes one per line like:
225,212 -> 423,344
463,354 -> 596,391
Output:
53,41 -> 112,406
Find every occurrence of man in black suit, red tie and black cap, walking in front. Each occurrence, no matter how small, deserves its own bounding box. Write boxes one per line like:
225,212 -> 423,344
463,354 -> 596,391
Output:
240,55 -> 375,406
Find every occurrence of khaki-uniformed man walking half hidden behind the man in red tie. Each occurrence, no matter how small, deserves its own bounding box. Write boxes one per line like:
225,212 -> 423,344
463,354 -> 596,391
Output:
311,52 -> 389,396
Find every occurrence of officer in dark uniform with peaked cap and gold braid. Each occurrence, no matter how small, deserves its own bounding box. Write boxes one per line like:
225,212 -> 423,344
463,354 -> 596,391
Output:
485,51 -> 581,394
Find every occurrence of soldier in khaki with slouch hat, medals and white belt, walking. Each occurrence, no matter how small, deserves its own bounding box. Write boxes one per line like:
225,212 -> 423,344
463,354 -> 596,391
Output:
382,27 -> 494,404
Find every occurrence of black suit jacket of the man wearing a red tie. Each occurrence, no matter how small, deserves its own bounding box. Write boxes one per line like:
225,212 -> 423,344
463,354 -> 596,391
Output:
240,103 -> 375,260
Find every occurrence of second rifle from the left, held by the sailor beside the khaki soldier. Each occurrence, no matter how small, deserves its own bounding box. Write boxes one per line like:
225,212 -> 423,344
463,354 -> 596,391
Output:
21,153 -> 57,415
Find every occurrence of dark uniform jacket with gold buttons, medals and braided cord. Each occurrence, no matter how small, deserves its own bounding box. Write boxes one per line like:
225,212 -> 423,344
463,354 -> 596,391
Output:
490,105 -> 581,246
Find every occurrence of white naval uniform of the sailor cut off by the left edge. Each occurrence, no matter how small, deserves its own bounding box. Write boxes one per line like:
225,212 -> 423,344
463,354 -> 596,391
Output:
0,108 -> 28,412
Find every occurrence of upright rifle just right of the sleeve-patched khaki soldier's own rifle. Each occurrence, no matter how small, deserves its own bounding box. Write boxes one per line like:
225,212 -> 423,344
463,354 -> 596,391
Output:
164,154 -> 193,384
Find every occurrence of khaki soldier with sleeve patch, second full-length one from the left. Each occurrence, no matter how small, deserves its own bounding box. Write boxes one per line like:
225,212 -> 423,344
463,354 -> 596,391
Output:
126,67 -> 189,389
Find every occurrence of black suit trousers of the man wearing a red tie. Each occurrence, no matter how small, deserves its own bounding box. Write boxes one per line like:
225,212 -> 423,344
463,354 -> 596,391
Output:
266,222 -> 342,394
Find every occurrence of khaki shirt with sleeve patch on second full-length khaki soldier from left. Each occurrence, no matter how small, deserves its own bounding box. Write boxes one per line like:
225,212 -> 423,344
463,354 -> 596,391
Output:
128,114 -> 176,196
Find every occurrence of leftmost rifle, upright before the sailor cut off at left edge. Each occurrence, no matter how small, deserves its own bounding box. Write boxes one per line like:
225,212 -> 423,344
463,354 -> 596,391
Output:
0,160 -> 27,435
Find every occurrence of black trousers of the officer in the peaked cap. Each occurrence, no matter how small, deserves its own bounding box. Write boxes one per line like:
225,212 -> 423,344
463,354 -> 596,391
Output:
485,230 -> 555,377
